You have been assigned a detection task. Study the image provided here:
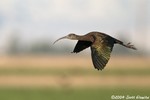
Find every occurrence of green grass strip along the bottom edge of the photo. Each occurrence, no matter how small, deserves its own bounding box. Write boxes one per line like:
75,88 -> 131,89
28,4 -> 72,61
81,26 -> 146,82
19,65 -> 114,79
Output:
0,88 -> 150,100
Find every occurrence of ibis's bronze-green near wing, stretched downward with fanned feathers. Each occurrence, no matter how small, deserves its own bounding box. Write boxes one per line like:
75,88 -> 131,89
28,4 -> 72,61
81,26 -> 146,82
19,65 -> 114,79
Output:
91,37 -> 114,70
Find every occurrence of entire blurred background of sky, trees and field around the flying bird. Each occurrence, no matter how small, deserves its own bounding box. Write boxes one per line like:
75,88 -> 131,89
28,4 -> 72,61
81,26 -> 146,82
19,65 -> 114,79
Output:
0,0 -> 150,100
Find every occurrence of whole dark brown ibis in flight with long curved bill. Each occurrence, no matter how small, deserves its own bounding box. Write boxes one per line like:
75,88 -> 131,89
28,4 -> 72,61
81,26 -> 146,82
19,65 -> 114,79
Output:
53,32 -> 136,70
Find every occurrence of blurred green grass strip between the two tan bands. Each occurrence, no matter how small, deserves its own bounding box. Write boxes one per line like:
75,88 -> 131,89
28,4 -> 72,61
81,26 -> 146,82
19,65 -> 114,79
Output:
0,67 -> 150,76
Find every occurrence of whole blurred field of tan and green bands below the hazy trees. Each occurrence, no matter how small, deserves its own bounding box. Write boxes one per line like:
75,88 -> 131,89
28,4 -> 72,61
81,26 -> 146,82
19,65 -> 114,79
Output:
0,55 -> 150,100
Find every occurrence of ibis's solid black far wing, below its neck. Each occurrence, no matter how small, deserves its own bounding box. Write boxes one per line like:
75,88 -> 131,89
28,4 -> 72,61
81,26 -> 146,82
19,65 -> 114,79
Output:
73,40 -> 92,53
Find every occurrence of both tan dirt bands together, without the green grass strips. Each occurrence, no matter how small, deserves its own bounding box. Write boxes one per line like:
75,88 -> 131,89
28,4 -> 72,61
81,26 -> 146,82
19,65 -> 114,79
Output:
0,56 -> 150,87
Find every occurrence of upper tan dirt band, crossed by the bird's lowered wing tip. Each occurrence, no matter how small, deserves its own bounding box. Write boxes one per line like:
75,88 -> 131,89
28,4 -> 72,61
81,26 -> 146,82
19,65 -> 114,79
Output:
0,56 -> 150,68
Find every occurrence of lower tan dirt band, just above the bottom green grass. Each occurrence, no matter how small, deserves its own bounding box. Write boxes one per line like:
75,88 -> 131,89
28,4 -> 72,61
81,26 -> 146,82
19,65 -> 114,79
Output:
0,75 -> 150,88
